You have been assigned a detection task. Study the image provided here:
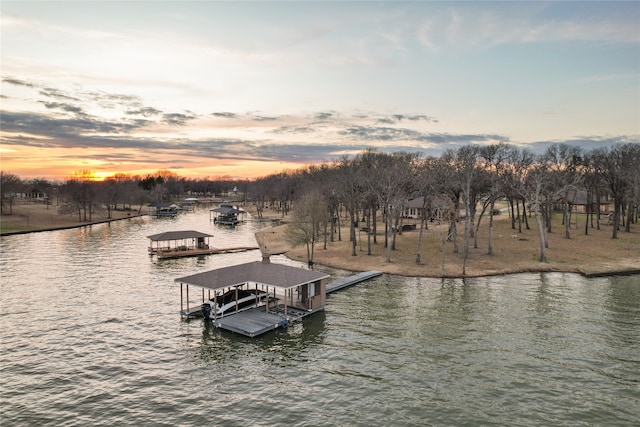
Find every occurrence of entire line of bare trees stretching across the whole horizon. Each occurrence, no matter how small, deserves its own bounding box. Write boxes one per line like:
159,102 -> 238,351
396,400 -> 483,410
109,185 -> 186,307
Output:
0,143 -> 640,273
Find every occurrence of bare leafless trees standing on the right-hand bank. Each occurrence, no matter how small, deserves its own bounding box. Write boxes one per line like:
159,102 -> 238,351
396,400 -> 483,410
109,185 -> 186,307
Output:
272,143 -> 640,274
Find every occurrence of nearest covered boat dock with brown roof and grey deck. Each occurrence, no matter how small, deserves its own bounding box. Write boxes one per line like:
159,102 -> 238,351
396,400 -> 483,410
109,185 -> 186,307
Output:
175,255 -> 329,337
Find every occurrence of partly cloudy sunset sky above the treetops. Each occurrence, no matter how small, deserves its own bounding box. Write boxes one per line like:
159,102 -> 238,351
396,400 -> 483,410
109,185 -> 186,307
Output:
0,0 -> 640,179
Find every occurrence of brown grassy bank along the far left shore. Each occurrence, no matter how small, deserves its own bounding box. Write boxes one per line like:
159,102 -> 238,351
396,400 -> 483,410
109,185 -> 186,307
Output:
0,203 -> 146,235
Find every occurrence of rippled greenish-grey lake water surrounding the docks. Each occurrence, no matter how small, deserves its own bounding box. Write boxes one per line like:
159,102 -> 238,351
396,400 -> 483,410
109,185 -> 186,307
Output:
0,208 -> 640,427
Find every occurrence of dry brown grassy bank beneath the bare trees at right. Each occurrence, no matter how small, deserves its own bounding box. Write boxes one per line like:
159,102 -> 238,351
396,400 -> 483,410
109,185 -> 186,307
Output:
256,215 -> 640,277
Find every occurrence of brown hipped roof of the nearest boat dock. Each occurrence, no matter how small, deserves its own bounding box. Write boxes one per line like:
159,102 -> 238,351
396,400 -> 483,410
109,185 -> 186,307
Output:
175,261 -> 329,289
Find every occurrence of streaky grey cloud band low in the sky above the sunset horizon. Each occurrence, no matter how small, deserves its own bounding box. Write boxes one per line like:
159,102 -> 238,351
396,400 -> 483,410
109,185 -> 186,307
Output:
0,77 -> 640,176
